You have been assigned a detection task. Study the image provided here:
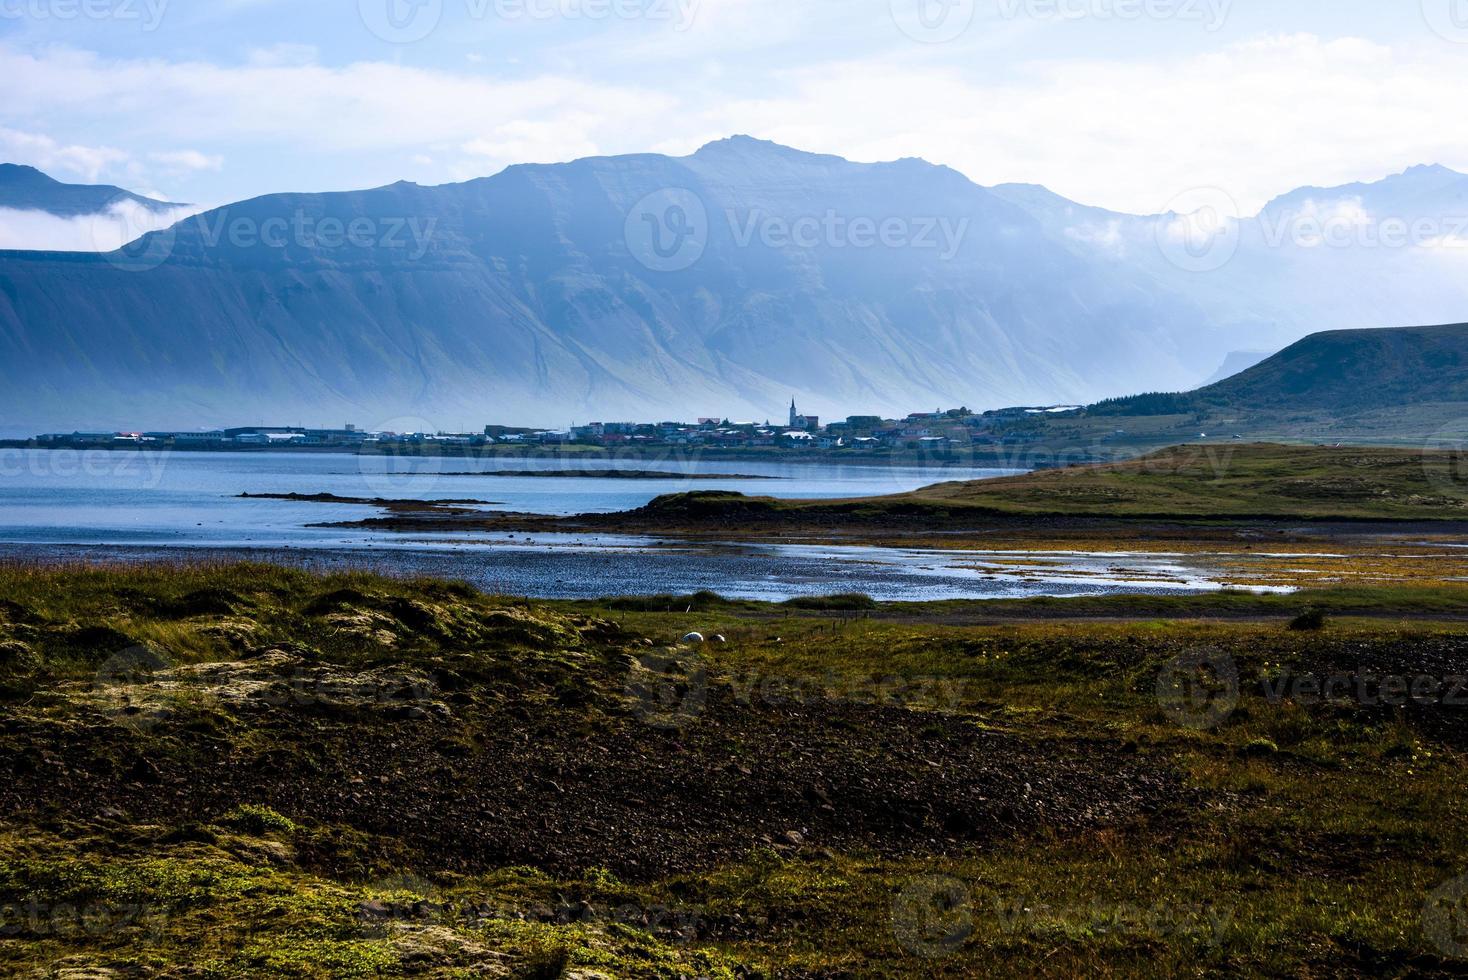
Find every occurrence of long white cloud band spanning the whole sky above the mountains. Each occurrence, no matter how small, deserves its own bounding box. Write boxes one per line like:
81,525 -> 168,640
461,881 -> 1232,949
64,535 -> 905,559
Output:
0,33 -> 1468,213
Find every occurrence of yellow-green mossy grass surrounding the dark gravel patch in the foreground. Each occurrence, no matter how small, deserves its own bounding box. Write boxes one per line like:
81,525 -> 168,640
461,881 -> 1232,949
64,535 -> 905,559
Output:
0,566 -> 1468,977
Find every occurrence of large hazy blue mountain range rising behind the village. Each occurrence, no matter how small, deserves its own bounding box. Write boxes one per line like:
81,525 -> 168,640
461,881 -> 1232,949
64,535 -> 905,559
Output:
0,136 -> 1468,431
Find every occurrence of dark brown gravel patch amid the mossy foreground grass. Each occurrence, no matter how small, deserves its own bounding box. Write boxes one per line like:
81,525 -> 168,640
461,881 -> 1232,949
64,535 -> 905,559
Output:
0,674 -> 1179,880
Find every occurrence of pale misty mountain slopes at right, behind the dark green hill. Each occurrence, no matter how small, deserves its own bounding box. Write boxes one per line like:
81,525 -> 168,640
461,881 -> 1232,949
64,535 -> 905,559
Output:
995,166 -> 1468,351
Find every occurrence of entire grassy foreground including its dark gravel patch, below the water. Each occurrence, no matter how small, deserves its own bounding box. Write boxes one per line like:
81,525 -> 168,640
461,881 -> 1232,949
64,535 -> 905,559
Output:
0,566 -> 1468,979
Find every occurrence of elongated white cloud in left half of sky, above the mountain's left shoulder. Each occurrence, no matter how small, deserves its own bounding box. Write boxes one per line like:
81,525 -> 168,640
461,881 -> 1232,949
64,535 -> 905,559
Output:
0,48 -> 677,178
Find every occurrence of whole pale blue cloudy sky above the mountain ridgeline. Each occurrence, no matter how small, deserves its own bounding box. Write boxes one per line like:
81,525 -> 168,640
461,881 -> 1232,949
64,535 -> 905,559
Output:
0,0 -> 1468,214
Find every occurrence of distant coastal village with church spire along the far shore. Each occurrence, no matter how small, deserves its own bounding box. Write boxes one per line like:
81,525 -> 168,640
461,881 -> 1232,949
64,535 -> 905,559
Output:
20,401 -> 1080,452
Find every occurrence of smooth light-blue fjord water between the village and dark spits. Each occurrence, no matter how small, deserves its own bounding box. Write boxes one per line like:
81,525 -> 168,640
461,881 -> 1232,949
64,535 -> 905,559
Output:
0,449 -> 1009,547
